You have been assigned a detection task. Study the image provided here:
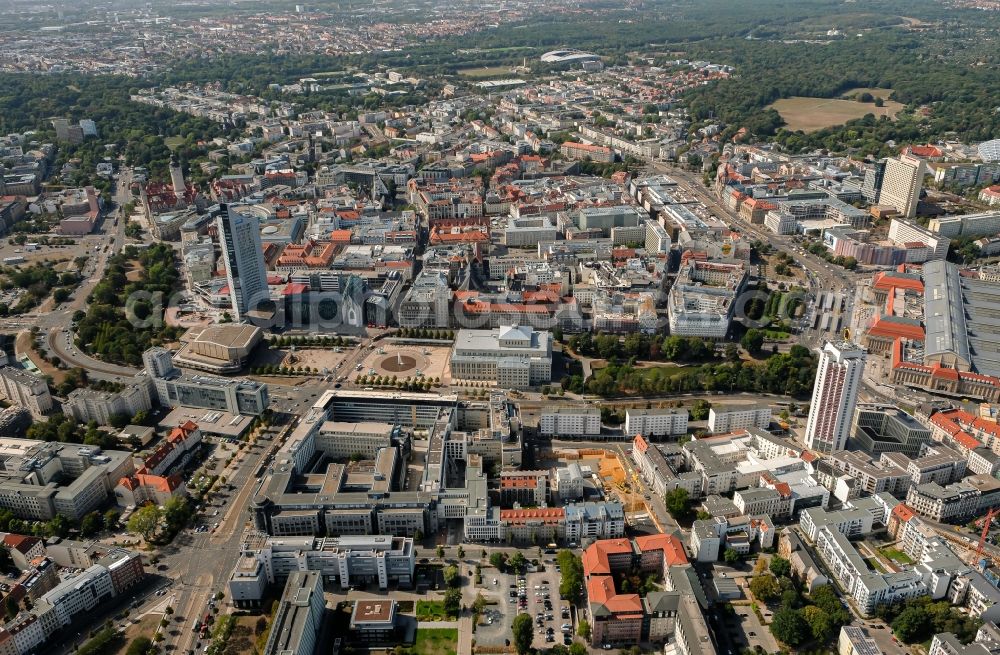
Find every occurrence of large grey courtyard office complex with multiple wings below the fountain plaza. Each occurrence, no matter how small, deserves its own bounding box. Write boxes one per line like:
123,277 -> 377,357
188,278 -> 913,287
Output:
251,390 -> 521,541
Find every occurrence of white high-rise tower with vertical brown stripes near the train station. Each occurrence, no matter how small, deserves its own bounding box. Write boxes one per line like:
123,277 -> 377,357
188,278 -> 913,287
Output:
806,341 -> 865,453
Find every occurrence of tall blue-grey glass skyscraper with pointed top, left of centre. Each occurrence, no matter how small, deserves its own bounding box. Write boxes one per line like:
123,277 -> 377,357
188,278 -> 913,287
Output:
215,205 -> 270,321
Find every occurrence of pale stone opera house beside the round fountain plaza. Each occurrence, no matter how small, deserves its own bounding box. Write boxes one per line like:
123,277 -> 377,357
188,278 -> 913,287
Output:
450,325 -> 552,389
